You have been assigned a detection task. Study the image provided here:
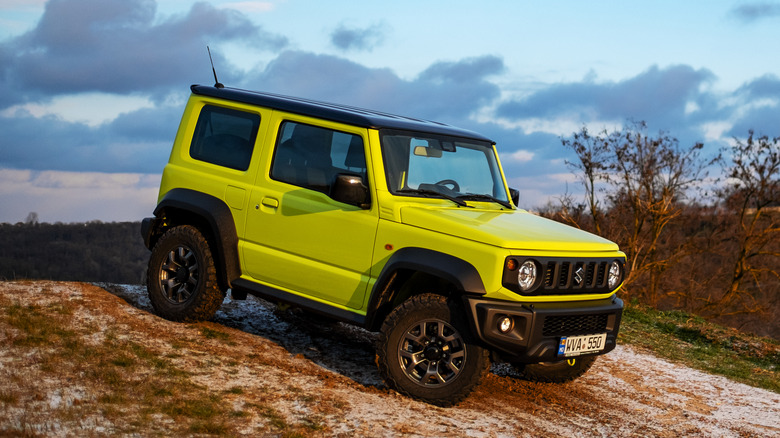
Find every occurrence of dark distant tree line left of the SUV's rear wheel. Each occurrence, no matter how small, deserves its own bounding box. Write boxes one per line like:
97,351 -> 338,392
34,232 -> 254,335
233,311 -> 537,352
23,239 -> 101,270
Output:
0,221 -> 149,284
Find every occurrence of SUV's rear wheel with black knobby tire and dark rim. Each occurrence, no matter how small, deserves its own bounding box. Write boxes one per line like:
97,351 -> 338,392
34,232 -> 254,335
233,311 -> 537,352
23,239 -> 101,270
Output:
146,225 -> 225,322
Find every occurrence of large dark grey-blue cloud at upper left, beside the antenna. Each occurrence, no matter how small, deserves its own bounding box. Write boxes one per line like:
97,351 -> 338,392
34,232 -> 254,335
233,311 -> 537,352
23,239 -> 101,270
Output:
0,0 -> 287,108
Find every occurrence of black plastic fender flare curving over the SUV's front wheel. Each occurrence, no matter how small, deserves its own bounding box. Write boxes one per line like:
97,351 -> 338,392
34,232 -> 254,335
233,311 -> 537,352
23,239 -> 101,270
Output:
366,247 -> 486,330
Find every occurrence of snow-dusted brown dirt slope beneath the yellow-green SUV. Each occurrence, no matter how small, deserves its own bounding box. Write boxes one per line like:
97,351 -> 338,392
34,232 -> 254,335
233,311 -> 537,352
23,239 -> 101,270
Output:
0,282 -> 780,437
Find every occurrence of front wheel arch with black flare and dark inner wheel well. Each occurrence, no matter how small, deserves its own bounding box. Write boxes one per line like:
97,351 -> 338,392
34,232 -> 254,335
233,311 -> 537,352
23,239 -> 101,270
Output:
365,247 -> 485,331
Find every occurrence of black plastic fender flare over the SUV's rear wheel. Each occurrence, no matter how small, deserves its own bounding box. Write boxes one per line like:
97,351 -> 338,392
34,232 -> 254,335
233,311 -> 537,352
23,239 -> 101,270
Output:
154,188 -> 241,288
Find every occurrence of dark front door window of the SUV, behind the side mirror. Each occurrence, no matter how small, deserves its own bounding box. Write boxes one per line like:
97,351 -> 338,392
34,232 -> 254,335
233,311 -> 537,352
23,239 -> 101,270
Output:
271,122 -> 368,194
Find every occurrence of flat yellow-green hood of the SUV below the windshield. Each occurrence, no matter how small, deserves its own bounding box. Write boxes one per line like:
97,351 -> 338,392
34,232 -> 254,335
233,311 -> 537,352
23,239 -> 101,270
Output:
401,206 -> 618,251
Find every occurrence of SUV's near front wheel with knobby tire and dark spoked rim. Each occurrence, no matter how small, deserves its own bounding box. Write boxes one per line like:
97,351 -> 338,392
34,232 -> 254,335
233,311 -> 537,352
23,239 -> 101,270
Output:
376,294 -> 490,406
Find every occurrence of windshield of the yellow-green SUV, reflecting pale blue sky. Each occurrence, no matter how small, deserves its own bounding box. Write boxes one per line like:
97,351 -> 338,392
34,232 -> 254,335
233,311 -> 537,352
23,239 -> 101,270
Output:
381,131 -> 509,203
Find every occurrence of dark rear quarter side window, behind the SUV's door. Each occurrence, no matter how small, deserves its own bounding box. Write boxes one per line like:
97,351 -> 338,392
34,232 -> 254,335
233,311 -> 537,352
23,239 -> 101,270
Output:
190,105 -> 260,170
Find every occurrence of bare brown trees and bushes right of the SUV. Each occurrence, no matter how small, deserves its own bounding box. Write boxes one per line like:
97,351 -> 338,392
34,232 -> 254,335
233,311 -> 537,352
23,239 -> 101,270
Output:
542,122 -> 780,338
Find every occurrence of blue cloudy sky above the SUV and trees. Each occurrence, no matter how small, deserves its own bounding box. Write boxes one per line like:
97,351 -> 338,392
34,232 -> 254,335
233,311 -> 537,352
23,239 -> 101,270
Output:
0,0 -> 780,223
